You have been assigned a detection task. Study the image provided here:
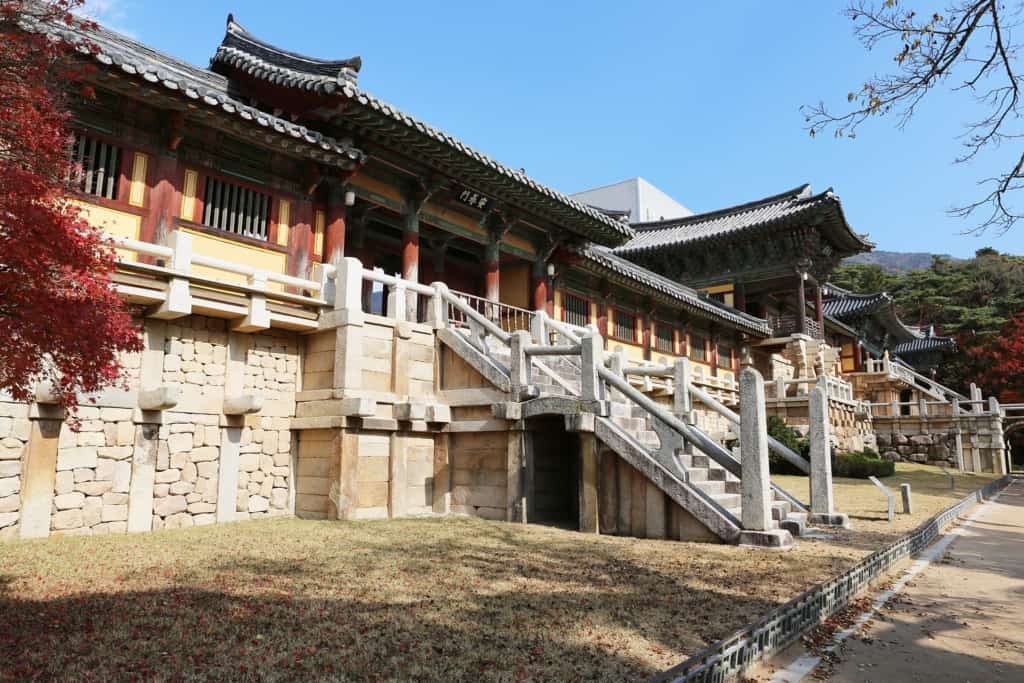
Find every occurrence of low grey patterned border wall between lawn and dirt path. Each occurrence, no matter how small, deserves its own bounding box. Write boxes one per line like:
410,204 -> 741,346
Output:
649,475 -> 1013,683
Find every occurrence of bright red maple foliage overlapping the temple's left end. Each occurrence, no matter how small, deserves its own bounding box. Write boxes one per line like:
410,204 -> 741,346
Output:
0,0 -> 141,409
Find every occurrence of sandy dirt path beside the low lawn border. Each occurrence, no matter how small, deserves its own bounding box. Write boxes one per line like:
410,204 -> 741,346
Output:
752,480 -> 1024,683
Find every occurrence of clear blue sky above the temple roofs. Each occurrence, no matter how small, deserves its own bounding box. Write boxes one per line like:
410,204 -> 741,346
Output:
92,0 -> 1024,256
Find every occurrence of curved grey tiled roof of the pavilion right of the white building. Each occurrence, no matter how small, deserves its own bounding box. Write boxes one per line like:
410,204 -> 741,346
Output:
615,184 -> 873,254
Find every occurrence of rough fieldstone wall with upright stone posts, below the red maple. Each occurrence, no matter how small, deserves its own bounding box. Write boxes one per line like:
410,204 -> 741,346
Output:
0,315 -> 301,538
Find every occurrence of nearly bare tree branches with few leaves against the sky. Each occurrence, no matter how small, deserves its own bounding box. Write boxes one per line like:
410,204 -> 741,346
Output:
801,0 -> 1024,233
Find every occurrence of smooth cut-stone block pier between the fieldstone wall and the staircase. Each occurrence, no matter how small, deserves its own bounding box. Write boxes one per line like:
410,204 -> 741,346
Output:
292,314 -> 444,519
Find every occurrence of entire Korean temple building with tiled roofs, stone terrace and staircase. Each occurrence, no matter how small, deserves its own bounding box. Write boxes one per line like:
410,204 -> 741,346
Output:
0,16 -> 1006,545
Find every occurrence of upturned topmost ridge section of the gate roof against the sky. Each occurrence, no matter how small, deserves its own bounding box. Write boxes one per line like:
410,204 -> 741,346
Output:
210,14 -> 362,95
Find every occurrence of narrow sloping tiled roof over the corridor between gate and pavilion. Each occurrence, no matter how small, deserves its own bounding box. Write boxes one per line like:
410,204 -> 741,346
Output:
577,245 -> 771,337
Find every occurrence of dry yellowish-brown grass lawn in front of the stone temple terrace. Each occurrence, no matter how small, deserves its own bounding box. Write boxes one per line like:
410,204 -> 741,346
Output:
0,465 -> 988,681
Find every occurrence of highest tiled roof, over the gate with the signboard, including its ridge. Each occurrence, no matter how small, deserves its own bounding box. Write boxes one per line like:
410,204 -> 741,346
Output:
212,17 -> 633,245
